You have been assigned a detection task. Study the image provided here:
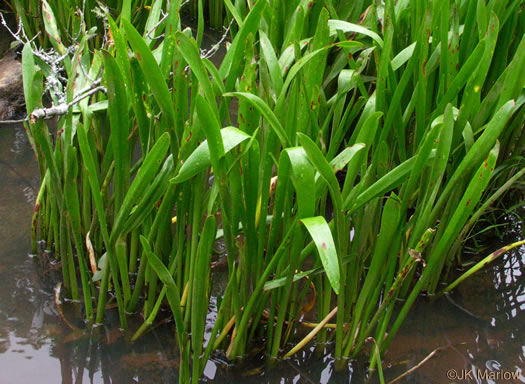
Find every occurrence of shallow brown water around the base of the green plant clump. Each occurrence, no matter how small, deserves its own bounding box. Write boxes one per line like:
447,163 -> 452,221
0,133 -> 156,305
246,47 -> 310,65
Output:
0,118 -> 525,383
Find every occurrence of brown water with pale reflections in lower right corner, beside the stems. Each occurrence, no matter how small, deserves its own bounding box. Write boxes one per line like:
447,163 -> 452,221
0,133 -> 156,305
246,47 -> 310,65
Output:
387,240 -> 525,383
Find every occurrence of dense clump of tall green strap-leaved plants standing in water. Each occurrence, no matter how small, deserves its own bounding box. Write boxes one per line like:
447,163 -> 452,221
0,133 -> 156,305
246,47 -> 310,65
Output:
12,0 -> 525,382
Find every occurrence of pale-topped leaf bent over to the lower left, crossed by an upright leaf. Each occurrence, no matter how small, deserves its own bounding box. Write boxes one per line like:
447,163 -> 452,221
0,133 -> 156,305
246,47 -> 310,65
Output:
170,127 -> 250,183
